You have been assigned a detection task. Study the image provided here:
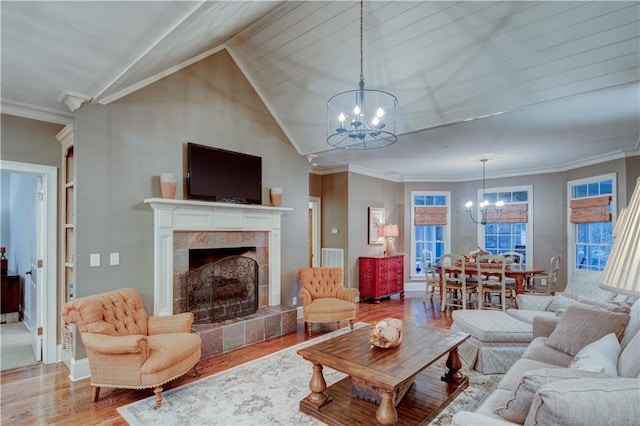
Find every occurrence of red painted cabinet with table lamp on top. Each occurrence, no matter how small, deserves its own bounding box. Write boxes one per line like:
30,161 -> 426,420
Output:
360,255 -> 404,302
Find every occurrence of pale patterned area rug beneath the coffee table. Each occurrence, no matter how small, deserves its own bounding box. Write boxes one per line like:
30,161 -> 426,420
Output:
118,323 -> 500,426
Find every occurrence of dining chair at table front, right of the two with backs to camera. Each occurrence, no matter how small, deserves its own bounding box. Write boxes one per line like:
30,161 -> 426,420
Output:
476,255 -> 515,311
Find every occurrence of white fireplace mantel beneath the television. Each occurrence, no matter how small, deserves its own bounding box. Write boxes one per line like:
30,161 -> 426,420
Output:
144,198 -> 293,316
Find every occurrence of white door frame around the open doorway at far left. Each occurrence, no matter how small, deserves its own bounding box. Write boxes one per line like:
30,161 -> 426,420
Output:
0,160 -> 61,364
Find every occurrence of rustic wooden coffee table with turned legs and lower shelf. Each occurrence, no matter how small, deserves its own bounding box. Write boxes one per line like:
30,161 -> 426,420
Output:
298,325 -> 469,426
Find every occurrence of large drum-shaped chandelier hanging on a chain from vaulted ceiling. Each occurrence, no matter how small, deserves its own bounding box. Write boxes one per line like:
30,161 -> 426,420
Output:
327,0 -> 398,150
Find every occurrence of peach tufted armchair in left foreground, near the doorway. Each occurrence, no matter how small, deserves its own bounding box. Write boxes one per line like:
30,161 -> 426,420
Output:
62,288 -> 201,408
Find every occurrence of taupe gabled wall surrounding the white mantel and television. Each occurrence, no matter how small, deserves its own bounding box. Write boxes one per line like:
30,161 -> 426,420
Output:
75,51 -> 309,312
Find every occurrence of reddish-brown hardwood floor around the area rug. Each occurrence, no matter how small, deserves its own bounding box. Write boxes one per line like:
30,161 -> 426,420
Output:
0,292 -> 452,425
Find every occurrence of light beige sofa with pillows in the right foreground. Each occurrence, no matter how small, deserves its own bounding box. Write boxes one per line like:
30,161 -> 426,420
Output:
452,299 -> 640,426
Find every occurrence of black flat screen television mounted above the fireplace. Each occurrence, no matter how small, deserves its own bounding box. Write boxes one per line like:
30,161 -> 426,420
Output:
187,142 -> 262,204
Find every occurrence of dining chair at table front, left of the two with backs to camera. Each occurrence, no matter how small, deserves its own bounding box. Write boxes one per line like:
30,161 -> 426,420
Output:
440,253 -> 477,311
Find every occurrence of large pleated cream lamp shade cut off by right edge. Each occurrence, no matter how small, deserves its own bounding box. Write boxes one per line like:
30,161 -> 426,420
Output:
600,178 -> 640,296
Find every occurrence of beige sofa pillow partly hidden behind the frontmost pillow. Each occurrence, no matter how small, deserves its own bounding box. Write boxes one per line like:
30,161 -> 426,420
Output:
494,368 -> 606,424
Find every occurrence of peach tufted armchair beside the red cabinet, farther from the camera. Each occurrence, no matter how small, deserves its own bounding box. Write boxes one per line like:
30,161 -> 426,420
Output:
298,268 -> 360,336
